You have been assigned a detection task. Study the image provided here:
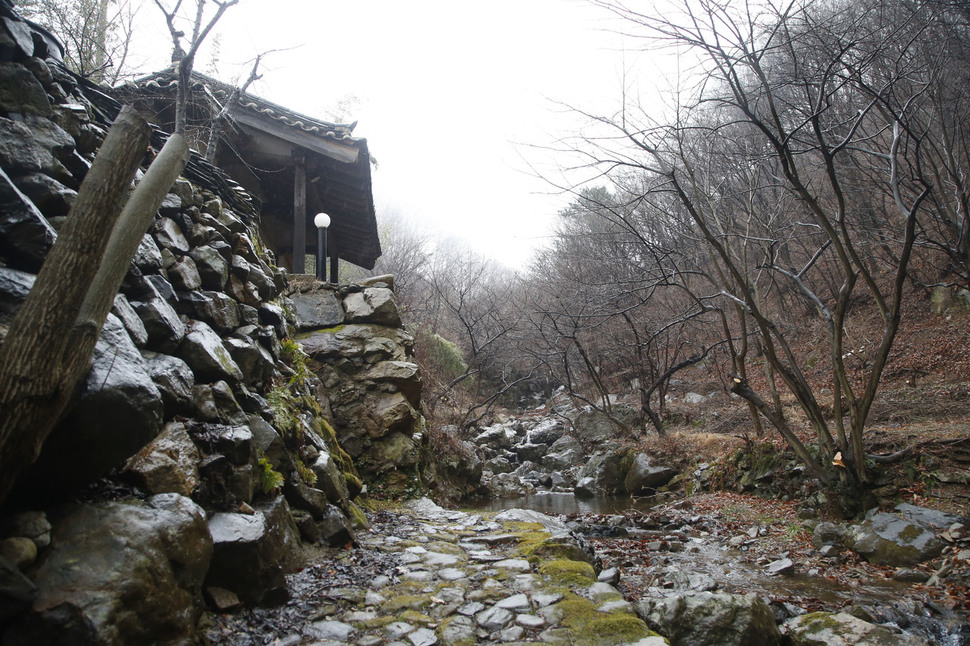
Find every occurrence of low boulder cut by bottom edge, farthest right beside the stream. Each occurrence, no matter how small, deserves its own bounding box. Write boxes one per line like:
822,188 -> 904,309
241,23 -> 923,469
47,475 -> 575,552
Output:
782,612 -> 931,646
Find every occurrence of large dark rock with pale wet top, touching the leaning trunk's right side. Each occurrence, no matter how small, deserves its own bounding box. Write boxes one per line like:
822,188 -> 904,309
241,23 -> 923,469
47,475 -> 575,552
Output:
18,314 -> 164,497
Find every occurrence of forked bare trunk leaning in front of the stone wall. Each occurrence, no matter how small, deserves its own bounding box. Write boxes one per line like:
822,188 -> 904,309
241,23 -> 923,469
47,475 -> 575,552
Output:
0,107 -> 189,503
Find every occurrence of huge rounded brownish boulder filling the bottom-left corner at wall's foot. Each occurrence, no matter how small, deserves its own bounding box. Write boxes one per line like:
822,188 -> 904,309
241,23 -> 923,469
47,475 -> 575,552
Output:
4,494 -> 212,646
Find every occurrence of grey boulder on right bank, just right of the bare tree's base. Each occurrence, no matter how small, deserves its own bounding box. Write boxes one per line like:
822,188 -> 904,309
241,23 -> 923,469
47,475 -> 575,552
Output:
842,510 -> 945,567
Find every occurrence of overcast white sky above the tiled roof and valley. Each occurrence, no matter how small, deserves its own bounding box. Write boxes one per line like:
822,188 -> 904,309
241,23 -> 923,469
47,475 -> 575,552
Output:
134,0 -> 652,266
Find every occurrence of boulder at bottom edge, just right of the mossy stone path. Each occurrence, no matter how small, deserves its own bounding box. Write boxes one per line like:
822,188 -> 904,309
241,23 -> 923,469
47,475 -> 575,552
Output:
637,592 -> 781,646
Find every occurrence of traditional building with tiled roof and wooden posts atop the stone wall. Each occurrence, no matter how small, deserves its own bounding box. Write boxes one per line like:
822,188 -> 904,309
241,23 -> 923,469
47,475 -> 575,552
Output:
117,68 -> 381,282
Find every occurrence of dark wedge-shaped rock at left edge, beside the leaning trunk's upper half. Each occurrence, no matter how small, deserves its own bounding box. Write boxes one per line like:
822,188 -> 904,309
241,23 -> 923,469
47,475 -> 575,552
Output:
0,168 -> 57,272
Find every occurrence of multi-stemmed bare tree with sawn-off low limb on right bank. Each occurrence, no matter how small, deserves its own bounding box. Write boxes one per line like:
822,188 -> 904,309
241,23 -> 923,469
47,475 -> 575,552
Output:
588,0 -> 930,498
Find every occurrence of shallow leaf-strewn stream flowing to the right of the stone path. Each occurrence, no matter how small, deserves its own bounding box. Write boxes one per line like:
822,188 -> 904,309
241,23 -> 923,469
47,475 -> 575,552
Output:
464,493 -> 970,646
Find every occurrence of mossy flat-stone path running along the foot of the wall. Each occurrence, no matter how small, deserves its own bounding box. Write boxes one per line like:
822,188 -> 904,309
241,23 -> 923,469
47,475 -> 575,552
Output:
208,499 -> 667,646
